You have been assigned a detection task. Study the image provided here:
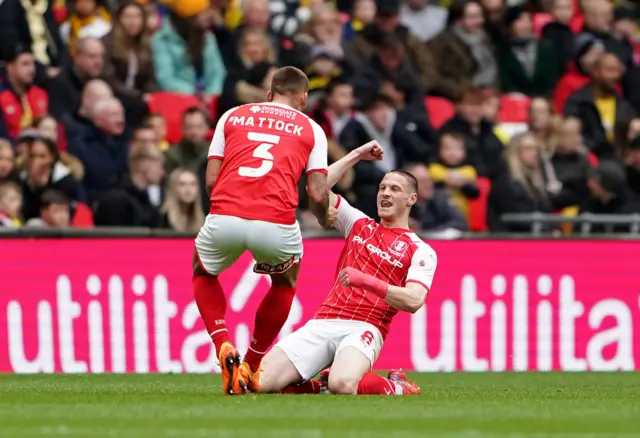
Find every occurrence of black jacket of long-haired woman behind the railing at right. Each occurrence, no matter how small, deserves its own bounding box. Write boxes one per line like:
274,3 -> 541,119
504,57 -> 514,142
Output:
487,175 -> 553,232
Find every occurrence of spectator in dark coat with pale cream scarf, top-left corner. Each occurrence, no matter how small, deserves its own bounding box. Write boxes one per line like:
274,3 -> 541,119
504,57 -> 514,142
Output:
0,0 -> 66,84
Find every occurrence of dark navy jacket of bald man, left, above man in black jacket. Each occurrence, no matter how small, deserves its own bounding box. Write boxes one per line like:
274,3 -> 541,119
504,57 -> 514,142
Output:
68,127 -> 129,205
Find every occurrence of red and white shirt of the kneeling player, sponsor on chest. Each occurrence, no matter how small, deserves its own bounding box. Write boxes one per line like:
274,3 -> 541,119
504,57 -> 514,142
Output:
314,197 -> 438,337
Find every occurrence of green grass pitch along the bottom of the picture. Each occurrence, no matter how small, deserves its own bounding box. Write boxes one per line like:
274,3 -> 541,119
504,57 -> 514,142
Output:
0,373 -> 640,438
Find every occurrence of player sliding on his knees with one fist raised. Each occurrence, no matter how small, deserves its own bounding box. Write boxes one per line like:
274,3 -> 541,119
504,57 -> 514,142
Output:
240,142 -> 437,395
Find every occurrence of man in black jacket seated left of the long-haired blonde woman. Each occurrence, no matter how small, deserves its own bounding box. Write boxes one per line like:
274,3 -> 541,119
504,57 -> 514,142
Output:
94,140 -> 164,228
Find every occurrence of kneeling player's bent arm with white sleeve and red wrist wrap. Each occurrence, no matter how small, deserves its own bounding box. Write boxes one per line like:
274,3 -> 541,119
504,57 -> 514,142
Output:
338,245 -> 438,313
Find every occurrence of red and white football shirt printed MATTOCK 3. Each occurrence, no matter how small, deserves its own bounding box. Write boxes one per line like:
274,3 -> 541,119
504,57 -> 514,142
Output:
209,103 -> 327,225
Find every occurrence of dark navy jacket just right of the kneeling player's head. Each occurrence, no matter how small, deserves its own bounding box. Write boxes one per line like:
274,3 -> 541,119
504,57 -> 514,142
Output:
410,189 -> 467,231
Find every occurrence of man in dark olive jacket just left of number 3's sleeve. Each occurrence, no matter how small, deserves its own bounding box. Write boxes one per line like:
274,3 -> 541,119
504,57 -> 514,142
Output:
164,108 -> 209,175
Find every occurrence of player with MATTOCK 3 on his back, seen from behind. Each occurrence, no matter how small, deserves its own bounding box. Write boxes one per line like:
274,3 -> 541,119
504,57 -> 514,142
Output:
193,67 -> 329,395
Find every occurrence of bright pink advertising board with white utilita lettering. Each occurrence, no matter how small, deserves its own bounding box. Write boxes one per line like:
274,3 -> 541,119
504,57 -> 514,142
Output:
0,239 -> 640,373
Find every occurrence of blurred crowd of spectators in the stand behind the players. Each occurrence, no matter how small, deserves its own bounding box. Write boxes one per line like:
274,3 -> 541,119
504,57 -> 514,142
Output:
0,0 -> 640,235
